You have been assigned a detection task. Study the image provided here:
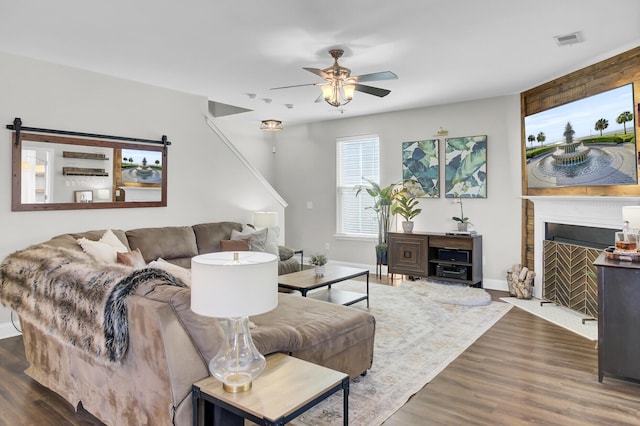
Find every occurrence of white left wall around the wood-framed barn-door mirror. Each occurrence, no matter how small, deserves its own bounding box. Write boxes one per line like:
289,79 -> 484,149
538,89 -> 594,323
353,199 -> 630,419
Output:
0,53 -> 283,337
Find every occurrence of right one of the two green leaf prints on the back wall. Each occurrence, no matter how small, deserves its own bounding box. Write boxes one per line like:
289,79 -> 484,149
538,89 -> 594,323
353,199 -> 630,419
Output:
445,135 -> 487,198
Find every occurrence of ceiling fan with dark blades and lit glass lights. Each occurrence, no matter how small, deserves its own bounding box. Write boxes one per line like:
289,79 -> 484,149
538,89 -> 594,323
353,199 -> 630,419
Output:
271,49 -> 398,107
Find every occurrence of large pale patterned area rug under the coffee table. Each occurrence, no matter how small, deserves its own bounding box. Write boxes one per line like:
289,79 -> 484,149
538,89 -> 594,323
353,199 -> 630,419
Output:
291,281 -> 512,426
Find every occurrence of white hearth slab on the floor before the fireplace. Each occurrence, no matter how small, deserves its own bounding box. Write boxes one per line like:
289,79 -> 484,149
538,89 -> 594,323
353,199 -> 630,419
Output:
500,297 -> 598,342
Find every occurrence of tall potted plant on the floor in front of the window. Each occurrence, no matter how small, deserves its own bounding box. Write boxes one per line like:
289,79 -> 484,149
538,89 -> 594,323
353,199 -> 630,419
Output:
356,178 -> 404,265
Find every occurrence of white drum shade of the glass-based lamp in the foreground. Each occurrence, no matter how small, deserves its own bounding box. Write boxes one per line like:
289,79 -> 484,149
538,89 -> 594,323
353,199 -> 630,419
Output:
191,251 -> 278,318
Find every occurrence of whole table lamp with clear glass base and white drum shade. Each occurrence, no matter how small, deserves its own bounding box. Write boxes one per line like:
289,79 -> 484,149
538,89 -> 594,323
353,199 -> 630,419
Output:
191,251 -> 278,393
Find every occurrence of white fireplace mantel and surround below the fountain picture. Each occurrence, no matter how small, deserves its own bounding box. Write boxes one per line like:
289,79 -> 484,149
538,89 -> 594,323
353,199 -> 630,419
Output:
522,196 -> 640,298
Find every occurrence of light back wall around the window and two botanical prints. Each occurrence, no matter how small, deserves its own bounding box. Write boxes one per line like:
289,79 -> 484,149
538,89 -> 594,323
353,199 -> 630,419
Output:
275,95 -> 521,290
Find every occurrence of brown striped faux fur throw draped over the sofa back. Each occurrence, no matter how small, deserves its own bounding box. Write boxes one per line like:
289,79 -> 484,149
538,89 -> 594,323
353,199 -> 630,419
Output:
0,244 -> 183,362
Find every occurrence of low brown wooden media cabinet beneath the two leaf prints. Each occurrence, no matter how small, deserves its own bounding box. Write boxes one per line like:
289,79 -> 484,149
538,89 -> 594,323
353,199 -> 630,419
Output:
388,232 -> 482,287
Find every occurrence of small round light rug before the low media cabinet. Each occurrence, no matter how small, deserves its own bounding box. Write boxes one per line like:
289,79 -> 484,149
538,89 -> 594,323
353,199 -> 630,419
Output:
403,280 -> 491,306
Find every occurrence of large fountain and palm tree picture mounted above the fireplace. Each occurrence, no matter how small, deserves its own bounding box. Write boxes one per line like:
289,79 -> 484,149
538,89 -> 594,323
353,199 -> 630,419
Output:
524,83 -> 638,189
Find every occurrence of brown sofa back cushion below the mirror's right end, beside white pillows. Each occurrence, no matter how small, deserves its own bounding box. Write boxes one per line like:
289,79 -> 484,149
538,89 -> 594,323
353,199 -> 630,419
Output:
126,226 -> 198,263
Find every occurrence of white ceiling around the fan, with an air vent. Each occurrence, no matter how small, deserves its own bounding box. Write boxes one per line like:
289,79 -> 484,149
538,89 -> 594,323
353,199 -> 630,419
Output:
0,0 -> 640,126
